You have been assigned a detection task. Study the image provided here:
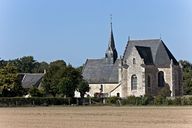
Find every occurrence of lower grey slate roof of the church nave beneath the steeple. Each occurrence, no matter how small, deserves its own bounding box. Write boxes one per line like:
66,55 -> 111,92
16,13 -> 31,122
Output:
82,58 -> 119,84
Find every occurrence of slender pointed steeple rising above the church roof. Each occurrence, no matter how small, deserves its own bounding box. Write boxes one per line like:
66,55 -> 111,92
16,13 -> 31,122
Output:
105,15 -> 118,63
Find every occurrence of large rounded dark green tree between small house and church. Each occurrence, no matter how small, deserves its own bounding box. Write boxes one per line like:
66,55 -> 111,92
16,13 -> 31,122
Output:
43,60 -> 82,97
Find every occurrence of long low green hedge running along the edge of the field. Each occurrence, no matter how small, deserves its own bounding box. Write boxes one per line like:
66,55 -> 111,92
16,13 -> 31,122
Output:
0,96 -> 192,107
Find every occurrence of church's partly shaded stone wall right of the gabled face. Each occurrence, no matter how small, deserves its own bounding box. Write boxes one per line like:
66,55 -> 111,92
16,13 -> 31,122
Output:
145,65 -> 182,96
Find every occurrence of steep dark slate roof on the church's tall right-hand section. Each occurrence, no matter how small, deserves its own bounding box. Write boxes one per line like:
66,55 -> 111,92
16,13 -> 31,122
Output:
123,39 -> 178,67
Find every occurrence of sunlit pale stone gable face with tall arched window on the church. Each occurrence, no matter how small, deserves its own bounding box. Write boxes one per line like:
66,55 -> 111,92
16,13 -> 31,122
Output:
122,47 -> 145,97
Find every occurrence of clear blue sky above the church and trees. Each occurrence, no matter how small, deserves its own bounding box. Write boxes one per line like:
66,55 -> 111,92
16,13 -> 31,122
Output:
0,0 -> 192,66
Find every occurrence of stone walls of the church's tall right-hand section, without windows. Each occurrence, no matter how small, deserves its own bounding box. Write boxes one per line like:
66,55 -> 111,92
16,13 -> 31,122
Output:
119,47 -> 183,97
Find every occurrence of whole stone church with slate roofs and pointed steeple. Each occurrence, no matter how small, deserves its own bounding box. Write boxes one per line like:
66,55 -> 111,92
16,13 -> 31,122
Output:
83,23 -> 183,97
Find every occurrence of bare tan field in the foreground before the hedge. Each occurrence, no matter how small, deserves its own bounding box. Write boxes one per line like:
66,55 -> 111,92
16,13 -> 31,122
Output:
0,107 -> 192,128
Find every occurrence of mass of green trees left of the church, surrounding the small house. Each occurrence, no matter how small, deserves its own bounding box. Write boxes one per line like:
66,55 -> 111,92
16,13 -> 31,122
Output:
0,56 -> 89,97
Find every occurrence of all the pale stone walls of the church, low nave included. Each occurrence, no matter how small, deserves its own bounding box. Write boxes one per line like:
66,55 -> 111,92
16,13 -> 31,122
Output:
86,39 -> 183,97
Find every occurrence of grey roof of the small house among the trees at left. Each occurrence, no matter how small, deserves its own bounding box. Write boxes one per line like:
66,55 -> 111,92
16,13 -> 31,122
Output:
19,73 -> 44,88
